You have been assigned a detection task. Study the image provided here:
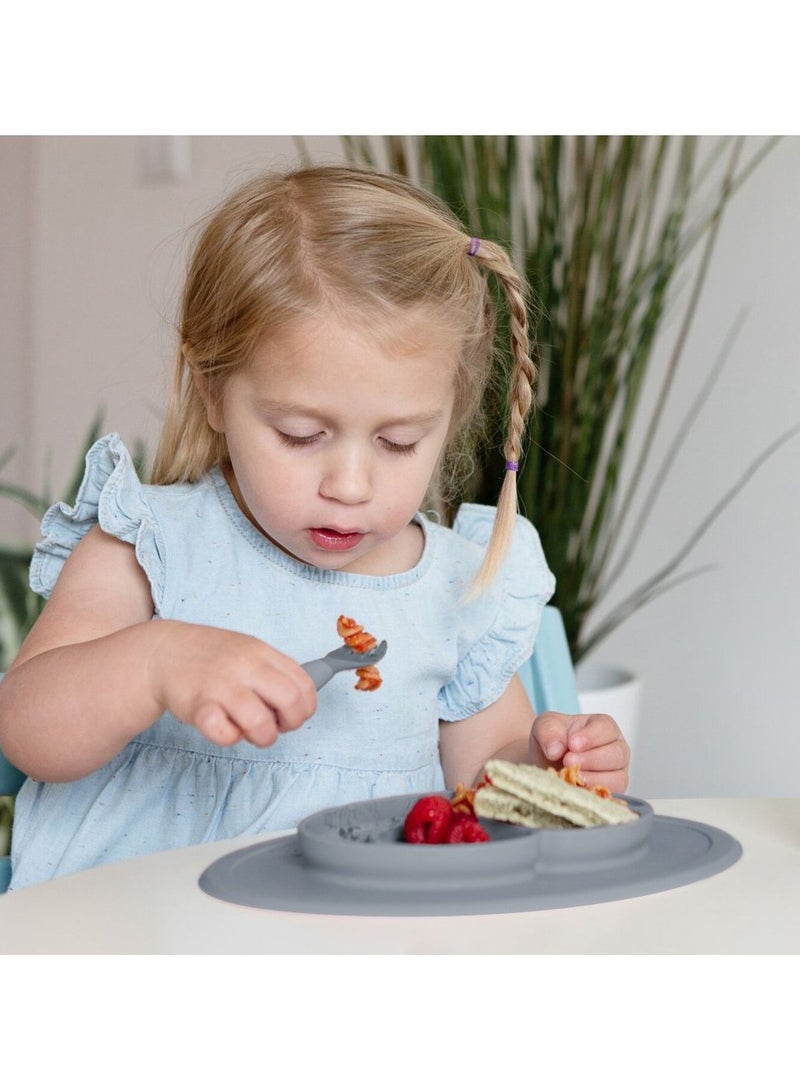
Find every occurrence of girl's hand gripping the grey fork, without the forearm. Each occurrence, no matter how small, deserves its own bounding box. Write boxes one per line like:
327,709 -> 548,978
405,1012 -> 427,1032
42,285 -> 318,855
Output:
146,621 -> 317,746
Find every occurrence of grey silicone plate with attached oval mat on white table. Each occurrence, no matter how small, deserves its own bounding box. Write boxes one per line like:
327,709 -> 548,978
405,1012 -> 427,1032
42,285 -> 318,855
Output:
200,795 -> 742,916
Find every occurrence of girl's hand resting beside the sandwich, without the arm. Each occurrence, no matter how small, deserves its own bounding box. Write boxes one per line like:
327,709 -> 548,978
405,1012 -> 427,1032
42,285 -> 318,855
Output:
530,712 -> 631,792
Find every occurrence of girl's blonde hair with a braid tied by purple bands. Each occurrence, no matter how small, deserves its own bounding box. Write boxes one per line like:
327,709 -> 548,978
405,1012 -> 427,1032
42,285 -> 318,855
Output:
152,166 -> 536,588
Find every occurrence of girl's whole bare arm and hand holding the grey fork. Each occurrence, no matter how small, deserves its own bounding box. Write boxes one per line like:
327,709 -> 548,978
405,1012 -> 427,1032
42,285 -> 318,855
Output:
0,529 -> 317,780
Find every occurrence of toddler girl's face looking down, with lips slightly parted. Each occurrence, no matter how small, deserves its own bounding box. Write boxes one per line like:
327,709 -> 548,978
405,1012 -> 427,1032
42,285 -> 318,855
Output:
203,316 -> 456,575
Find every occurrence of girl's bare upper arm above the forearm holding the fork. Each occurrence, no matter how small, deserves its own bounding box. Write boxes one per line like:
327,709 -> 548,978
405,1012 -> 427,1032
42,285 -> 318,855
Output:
16,527 -> 153,663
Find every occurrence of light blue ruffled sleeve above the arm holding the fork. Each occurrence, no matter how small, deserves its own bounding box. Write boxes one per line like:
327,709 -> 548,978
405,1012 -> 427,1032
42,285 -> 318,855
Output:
31,432 -> 165,612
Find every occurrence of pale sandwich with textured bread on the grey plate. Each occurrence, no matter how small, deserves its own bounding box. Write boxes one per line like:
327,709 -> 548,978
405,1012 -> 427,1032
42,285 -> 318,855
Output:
474,759 -> 638,829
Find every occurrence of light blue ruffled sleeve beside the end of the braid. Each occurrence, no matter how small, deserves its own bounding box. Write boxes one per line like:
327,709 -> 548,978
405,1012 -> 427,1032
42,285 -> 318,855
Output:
439,504 -> 556,720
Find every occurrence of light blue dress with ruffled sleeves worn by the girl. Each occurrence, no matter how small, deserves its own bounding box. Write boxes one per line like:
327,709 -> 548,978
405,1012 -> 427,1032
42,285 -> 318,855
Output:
7,434 -> 553,889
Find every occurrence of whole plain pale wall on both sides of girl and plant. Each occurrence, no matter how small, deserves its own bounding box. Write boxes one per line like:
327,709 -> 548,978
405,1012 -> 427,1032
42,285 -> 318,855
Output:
0,136 -> 800,798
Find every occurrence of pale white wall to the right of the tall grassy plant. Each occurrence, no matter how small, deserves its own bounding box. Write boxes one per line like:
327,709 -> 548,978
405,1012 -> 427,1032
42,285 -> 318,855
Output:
595,137 -> 800,796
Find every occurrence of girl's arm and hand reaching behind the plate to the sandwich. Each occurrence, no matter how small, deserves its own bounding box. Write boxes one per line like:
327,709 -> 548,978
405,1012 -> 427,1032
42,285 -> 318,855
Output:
439,676 -> 631,792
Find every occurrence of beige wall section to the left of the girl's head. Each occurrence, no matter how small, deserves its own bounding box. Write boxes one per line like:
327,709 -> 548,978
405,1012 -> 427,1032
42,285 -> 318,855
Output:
21,136 -> 341,490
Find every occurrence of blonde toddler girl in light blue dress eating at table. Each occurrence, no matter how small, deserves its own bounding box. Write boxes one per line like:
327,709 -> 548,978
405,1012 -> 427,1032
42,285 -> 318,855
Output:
0,167 -> 629,888
